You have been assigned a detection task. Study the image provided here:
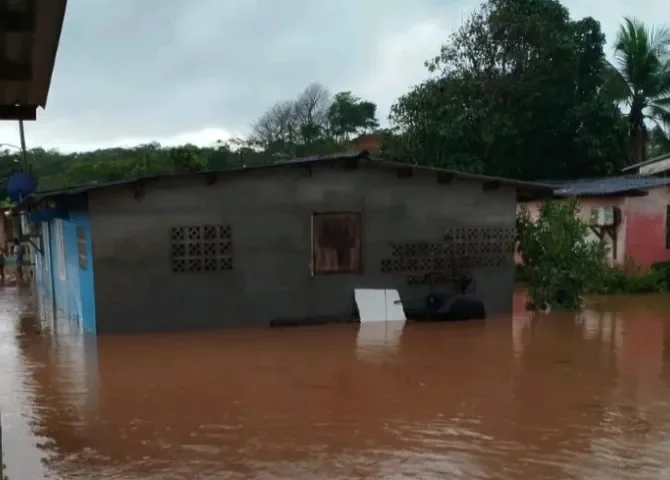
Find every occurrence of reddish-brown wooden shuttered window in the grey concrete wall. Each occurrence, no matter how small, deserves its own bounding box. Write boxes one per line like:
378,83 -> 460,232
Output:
312,212 -> 363,275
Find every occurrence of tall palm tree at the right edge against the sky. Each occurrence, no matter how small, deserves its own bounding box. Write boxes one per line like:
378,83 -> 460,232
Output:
609,18 -> 670,163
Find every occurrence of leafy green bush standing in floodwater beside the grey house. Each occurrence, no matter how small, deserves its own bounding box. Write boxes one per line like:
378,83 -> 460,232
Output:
517,199 -> 607,309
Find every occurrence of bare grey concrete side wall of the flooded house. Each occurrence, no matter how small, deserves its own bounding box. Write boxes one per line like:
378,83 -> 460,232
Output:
89,166 -> 516,333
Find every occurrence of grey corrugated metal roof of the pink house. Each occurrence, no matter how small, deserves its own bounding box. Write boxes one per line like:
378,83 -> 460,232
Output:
547,175 -> 670,197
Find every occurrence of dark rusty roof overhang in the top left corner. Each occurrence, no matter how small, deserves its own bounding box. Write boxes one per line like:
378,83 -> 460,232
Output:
0,0 -> 67,120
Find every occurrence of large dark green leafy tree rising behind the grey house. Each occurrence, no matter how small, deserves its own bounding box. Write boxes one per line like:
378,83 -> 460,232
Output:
383,0 -> 625,179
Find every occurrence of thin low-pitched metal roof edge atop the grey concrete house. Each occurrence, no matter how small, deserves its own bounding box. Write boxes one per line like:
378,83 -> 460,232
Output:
17,151 -> 553,208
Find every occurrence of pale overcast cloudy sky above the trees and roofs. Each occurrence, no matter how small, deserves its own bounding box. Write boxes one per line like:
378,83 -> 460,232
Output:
0,0 -> 670,151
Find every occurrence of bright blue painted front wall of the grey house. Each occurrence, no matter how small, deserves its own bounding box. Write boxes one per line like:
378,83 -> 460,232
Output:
32,196 -> 96,333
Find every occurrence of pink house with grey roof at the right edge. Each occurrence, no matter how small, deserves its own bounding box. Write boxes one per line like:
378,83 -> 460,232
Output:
517,175 -> 670,268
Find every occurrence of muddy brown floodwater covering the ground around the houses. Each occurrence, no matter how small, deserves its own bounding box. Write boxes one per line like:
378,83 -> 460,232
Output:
0,288 -> 670,480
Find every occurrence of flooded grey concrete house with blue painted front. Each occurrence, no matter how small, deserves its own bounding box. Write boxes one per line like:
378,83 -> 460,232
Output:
15,152 -> 551,333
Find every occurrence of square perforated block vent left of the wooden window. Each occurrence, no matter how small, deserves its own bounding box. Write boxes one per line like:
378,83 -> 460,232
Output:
170,225 -> 233,273
